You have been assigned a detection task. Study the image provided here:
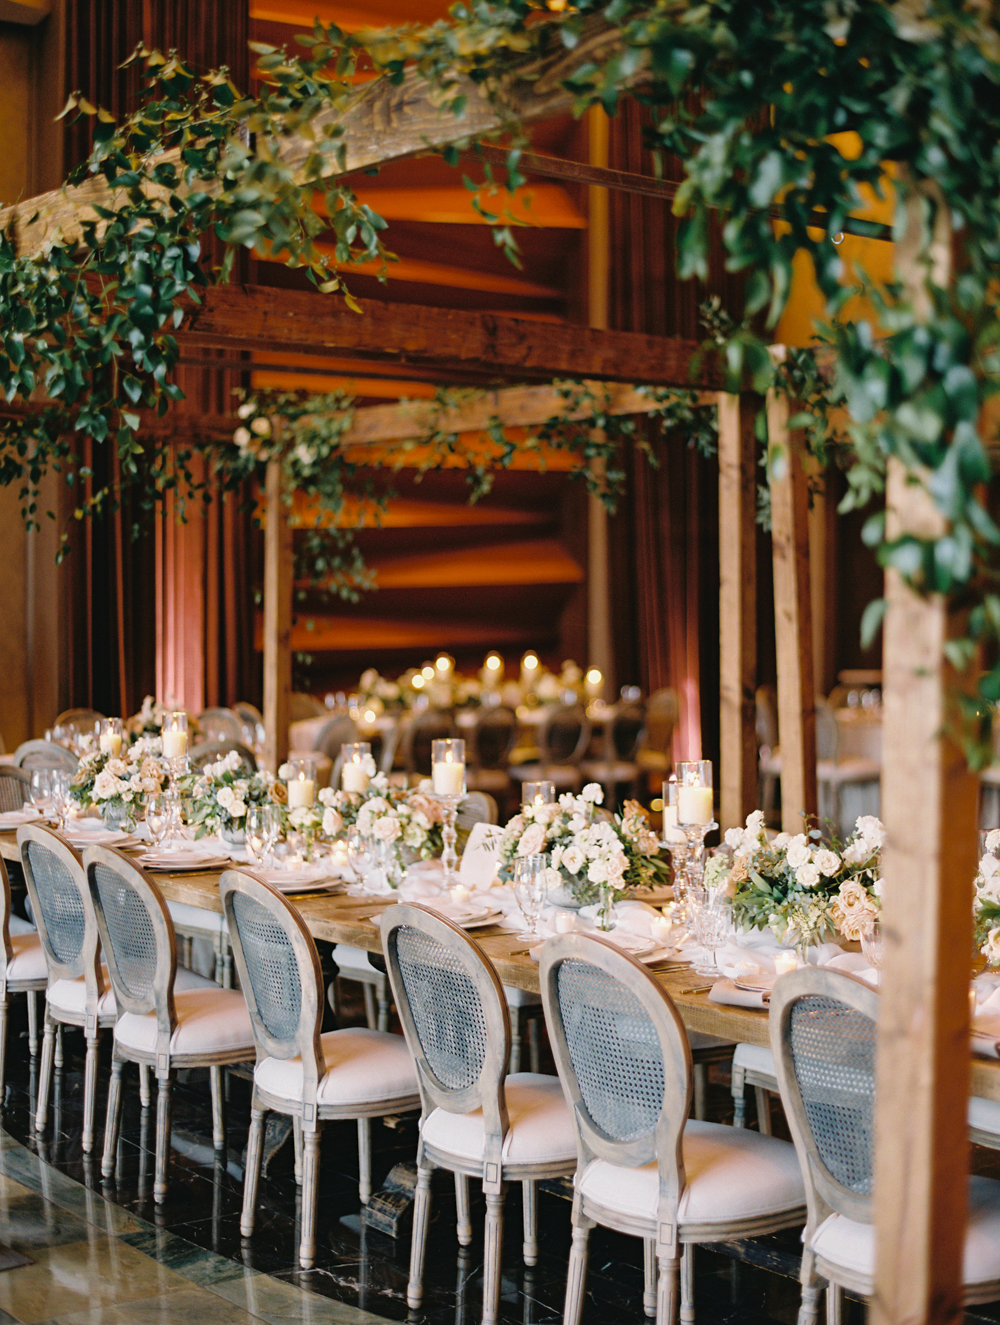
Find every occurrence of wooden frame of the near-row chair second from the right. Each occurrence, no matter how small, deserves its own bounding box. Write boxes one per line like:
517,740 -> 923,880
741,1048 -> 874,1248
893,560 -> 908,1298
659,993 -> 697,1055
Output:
539,934 -> 804,1325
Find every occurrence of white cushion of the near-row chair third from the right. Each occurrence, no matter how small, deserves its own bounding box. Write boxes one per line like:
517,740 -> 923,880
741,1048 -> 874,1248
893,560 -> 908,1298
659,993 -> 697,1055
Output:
423,1072 -> 576,1165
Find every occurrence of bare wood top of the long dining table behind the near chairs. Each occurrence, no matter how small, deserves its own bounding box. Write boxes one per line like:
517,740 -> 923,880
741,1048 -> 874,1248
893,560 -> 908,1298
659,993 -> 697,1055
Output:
7,832 -> 1000,1101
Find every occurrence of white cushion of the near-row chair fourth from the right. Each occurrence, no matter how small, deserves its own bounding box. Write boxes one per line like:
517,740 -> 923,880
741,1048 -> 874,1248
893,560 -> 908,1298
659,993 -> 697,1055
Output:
253,1026 -> 419,1108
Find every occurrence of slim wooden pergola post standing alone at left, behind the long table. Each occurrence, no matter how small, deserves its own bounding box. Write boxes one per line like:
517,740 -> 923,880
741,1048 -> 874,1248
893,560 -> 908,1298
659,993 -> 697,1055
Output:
264,453 -> 293,774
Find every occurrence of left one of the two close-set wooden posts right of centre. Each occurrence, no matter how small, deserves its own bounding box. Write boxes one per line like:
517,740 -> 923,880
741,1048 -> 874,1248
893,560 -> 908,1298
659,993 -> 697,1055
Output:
718,392 -> 762,831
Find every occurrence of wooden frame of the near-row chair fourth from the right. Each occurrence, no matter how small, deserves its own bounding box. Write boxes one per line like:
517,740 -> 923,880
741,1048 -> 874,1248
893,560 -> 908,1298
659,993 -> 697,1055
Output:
219,869 -> 420,1269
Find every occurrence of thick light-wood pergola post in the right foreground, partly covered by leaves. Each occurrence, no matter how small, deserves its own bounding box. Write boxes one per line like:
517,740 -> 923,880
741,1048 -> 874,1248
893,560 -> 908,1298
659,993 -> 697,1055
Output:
870,186 -> 977,1325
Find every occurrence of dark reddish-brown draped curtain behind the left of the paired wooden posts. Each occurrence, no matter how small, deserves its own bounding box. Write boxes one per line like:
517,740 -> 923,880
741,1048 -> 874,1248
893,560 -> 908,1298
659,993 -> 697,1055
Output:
609,101 -> 743,759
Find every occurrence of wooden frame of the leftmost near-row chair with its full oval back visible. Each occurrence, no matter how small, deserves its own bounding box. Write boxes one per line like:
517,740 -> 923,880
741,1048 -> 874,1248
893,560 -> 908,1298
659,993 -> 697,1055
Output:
17,824 -> 114,1154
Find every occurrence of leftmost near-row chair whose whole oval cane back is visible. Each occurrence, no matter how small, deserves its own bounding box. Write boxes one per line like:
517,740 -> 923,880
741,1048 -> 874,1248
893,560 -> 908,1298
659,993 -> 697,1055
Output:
17,824 -> 117,1154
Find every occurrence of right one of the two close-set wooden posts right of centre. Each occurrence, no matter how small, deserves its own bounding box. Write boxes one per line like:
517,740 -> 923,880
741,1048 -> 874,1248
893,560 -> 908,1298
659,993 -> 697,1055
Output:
767,391 -> 817,833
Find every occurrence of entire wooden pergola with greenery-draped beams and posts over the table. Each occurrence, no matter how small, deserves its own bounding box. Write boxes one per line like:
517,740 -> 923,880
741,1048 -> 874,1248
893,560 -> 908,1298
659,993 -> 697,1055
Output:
0,44 -> 977,1322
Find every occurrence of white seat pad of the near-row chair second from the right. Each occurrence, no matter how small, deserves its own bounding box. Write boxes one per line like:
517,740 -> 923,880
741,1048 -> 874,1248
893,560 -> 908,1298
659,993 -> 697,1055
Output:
577,1120 -> 805,1227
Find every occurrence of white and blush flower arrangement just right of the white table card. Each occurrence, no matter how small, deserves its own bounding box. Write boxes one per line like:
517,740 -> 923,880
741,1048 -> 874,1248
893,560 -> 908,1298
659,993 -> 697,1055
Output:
499,782 -> 669,906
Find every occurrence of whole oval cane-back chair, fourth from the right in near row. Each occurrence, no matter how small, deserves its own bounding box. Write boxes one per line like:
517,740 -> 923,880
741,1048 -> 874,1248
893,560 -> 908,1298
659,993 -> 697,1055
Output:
220,869 -> 420,1269
